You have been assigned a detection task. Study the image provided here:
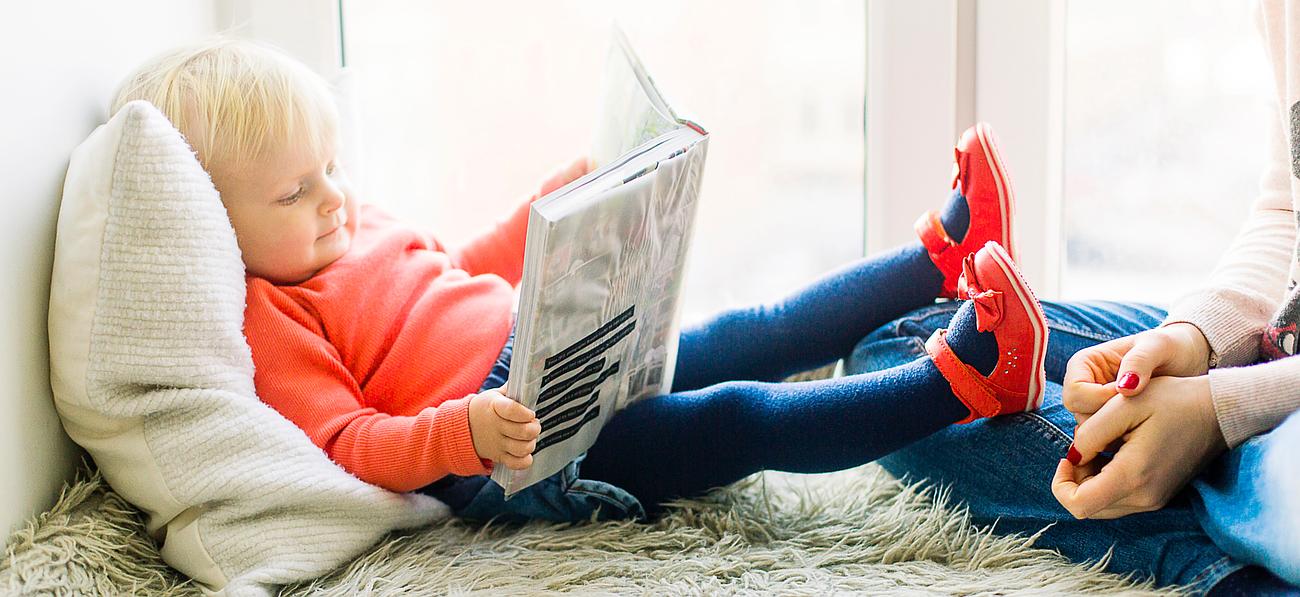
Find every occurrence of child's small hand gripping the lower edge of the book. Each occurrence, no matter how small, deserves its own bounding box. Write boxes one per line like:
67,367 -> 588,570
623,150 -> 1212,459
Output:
469,389 -> 542,471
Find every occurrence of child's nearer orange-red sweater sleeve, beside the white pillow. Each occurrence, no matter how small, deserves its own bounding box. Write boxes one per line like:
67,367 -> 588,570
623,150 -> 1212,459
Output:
244,284 -> 489,492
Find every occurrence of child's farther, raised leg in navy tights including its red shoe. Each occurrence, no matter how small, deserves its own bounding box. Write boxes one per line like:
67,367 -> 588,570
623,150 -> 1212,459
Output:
672,124 -> 1015,391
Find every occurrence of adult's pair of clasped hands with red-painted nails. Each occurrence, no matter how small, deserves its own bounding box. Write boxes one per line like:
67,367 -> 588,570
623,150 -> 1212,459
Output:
1052,323 -> 1227,519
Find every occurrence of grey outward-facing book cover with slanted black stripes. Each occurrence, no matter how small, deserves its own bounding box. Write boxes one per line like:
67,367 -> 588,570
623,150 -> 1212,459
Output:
493,139 -> 707,496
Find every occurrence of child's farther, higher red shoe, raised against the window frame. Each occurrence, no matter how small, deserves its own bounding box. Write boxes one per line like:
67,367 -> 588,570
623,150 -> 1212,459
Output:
915,122 -> 1015,298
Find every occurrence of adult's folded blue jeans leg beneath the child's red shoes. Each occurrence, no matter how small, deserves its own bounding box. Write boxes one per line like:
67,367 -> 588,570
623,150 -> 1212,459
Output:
846,302 -> 1243,593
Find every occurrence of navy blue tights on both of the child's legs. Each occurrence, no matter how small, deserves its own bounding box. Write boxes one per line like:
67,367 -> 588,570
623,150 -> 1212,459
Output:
582,243 -> 982,512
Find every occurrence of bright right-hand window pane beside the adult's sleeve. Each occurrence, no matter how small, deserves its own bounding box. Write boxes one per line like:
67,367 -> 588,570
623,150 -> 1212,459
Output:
1066,0 -> 1271,304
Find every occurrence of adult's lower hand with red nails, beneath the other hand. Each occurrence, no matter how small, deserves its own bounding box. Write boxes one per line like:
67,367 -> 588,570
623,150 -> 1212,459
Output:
1052,376 -> 1227,519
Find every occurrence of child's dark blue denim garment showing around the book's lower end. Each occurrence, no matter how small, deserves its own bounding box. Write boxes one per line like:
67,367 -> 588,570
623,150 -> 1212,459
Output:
416,330 -> 645,523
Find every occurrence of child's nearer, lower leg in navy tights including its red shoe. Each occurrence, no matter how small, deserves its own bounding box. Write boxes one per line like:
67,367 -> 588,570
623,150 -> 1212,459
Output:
582,243 -> 1048,512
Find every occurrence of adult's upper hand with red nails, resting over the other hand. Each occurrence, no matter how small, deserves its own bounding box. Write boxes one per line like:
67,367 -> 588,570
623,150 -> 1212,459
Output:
1061,323 -> 1210,424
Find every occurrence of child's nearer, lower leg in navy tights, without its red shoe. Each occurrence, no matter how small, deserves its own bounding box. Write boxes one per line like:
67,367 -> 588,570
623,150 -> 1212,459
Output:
582,358 -> 967,512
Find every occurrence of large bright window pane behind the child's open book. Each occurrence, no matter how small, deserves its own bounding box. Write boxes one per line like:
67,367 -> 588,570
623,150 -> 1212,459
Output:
343,0 -> 866,323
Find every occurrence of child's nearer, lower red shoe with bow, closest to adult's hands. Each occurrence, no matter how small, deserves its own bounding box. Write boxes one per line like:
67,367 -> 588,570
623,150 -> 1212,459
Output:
926,241 -> 1048,423
